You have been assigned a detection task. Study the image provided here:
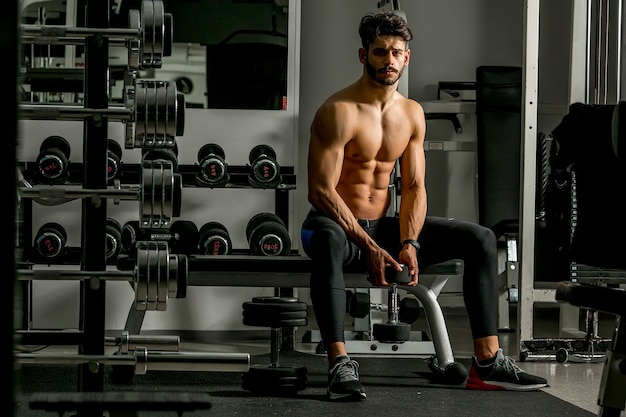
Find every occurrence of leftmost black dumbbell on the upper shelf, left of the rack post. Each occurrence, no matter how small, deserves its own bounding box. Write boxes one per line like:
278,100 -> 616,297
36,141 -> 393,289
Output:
36,135 -> 71,184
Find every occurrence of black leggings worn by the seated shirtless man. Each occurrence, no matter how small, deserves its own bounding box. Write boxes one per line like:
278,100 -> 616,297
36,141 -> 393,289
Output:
301,211 -> 498,347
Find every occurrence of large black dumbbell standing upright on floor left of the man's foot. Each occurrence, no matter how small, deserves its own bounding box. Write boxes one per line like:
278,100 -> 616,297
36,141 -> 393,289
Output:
241,297 -> 308,395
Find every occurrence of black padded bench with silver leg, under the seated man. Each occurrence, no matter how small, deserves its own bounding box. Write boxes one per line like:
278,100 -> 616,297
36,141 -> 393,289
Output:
180,255 -> 463,379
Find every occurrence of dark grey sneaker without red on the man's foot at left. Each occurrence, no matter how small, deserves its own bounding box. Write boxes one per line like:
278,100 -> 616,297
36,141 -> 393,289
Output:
327,355 -> 366,401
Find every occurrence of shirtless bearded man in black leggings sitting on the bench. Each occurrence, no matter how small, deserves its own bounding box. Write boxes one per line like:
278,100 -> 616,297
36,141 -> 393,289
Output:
301,13 -> 547,400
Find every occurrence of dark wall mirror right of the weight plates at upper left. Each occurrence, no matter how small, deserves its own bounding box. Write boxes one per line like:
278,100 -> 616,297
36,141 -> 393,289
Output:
154,0 -> 288,110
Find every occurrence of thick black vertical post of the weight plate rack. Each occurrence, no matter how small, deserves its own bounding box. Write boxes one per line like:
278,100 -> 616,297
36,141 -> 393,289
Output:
78,0 -> 111,391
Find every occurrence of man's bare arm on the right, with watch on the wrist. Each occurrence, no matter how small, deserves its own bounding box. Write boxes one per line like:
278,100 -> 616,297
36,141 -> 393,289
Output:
399,103 -> 427,283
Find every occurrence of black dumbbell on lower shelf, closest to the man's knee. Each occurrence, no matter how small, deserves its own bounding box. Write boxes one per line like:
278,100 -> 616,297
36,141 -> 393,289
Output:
246,212 -> 291,256
